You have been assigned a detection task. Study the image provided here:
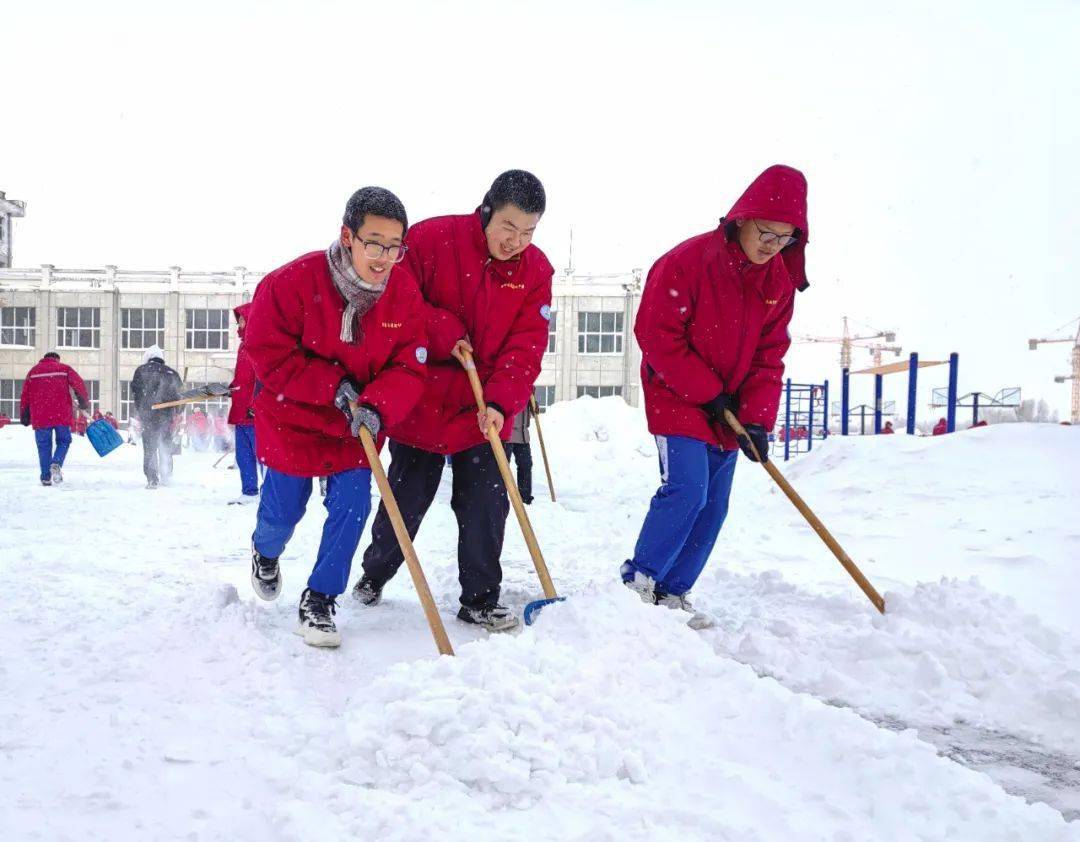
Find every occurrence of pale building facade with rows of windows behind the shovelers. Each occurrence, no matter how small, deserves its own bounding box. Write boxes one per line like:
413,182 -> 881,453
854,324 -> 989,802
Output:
0,266 -> 642,420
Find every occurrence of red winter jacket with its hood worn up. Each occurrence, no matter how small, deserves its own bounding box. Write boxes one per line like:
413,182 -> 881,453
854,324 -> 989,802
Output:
634,166 -> 809,450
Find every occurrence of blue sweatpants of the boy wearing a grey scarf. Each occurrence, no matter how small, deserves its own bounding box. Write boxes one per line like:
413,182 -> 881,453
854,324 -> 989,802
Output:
252,467 -> 372,596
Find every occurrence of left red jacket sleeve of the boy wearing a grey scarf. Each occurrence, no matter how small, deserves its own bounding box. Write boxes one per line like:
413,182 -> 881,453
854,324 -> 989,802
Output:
244,266 -> 347,406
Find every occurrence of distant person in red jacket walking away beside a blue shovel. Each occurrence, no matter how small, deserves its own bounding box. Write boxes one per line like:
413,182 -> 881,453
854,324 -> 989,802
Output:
19,351 -> 90,486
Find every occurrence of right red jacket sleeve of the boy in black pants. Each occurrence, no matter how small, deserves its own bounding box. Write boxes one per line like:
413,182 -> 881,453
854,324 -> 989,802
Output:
484,261 -> 555,418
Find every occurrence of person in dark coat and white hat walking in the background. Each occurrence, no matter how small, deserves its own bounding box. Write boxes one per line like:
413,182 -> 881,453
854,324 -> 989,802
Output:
132,345 -> 184,489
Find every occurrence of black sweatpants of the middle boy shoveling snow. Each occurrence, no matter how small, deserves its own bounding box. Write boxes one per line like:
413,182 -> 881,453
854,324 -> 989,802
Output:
364,442 -> 510,608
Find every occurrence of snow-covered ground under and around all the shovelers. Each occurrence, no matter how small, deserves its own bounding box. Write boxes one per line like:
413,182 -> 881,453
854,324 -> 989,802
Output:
0,398 -> 1080,842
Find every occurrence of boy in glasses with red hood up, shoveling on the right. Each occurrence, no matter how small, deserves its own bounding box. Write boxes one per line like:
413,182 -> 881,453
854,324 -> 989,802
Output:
621,165 -> 809,627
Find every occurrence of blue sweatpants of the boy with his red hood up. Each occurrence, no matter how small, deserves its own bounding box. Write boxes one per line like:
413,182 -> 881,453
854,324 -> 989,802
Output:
630,436 -> 739,595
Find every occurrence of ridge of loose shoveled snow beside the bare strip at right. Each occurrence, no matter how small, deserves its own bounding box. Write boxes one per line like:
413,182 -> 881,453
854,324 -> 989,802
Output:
708,571 -> 1080,756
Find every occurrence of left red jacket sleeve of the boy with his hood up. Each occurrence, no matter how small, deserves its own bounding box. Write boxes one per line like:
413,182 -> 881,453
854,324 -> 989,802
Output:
634,260 -> 726,404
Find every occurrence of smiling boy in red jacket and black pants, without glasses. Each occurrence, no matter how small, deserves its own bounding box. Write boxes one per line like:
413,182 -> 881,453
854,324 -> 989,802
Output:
353,169 -> 554,632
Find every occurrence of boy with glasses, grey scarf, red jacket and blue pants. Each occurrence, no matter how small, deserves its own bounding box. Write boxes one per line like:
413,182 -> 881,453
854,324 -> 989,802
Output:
244,187 -> 428,647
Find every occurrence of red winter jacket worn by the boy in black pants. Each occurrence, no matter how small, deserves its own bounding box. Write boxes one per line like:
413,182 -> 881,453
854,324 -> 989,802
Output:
390,212 -> 555,453
